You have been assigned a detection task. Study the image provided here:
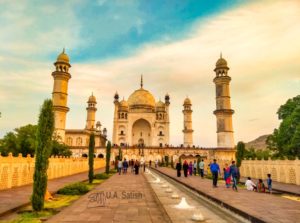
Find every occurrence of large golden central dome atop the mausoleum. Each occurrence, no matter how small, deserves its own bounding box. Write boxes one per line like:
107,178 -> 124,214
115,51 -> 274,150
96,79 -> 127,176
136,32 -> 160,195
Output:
128,88 -> 155,108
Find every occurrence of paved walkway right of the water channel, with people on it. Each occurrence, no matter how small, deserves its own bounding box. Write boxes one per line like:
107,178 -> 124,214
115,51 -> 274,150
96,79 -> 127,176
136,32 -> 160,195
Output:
157,167 -> 300,223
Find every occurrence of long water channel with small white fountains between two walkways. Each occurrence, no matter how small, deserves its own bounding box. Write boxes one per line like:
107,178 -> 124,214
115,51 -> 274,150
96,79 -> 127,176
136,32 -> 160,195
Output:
145,169 -> 250,223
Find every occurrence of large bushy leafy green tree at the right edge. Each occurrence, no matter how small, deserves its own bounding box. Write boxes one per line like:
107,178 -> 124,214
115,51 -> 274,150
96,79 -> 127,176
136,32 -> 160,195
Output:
267,95 -> 300,158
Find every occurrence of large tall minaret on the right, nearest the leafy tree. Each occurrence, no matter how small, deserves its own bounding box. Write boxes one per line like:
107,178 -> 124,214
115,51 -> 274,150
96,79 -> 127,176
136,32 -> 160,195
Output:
214,54 -> 234,148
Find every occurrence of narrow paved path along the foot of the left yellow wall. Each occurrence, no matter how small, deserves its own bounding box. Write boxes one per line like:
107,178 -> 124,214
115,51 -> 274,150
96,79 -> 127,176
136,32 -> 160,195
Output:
0,168 -> 104,216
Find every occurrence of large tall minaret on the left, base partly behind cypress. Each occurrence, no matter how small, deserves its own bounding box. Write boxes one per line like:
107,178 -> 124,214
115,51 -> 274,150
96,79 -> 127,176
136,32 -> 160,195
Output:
52,49 -> 71,143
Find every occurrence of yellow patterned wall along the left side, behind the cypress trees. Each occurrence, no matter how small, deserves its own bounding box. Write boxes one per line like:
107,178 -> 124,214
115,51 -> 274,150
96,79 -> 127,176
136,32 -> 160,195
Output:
0,153 -> 105,190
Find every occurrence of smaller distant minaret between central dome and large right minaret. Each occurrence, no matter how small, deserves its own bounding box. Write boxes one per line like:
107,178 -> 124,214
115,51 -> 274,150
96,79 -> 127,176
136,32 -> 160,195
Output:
182,98 -> 194,147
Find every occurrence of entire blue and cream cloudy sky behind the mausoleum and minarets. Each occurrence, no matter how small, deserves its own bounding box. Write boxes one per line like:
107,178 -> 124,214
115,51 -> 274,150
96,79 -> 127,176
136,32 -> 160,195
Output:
0,0 -> 300,147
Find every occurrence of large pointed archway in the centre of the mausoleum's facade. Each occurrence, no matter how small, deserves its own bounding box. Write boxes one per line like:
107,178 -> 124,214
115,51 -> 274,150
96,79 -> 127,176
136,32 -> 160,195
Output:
132,119 -> 152,147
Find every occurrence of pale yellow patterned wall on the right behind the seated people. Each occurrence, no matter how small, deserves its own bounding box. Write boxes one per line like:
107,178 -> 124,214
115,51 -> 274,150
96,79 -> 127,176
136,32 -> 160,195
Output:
240,159 -> 300,185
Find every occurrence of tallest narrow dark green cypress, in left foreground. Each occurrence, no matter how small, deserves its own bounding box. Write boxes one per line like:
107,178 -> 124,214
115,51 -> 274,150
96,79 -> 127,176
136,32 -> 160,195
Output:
31,99 -> 54,211
